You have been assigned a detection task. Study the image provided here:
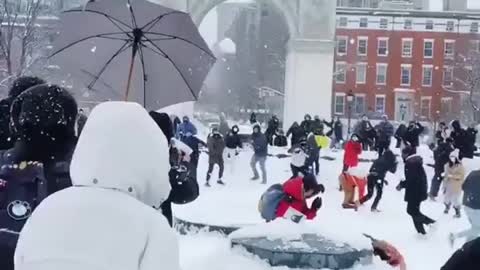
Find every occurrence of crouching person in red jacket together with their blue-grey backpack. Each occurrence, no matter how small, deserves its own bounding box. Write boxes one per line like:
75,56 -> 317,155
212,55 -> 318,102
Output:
259,174 -> 325,223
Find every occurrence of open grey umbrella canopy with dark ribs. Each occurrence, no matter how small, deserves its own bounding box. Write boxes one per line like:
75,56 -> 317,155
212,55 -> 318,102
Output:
51,0 -> 215,110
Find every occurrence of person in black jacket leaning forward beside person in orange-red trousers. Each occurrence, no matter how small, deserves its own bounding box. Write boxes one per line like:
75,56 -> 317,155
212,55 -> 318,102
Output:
360,150 -> 397,212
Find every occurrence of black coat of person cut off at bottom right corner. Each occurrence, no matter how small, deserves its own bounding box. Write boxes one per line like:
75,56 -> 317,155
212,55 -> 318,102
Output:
440,238 -> 480,270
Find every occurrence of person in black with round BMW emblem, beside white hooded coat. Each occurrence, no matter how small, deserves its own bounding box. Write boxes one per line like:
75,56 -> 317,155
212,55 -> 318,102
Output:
0,84 -> 78,270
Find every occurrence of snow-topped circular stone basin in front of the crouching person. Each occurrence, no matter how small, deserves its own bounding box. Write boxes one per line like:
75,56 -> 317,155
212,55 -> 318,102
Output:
231,234 -> 373,269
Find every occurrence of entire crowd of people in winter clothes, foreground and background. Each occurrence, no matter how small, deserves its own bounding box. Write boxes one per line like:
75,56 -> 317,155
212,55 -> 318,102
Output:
0,77 -> 480,270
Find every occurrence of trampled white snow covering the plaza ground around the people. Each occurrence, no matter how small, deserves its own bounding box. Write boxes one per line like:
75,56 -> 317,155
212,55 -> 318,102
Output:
174,142 -> 480,270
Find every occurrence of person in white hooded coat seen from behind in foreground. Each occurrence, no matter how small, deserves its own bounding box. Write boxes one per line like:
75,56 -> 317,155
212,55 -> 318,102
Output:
15,102 -> 180,270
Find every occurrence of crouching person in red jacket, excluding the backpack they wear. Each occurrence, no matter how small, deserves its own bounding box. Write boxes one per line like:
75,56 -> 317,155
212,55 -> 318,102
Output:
277,174 -> 325,219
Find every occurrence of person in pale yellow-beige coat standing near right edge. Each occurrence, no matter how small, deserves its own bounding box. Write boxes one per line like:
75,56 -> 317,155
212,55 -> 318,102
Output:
443,149 -> 465,218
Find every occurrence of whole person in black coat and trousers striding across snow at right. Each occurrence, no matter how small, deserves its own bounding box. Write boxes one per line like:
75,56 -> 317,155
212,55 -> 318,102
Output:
397,145 -> 435,235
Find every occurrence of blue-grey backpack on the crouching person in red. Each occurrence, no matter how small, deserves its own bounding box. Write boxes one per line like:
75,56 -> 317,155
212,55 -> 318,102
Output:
258,184 -> 287,222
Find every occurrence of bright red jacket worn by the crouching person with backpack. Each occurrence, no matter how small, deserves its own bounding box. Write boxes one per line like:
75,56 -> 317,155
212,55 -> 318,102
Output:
277,177 -> 317,219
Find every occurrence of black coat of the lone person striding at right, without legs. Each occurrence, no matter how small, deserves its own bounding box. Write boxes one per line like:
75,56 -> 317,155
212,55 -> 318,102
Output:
400,155 -> 428,202
